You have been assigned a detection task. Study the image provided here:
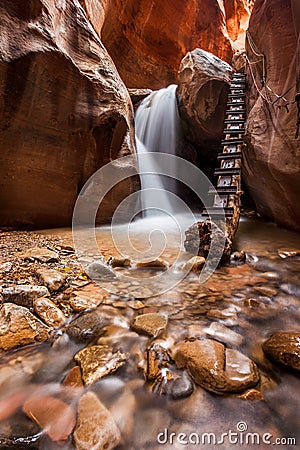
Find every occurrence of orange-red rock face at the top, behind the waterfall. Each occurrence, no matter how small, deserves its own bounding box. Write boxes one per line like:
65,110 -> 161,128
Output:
101,0 -> 234,89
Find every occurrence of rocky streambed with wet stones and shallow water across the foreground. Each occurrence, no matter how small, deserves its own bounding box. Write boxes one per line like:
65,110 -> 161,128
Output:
0,220 -> 300,450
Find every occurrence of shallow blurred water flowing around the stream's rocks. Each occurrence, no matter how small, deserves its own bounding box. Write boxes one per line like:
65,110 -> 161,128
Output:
0,219 -> 300,450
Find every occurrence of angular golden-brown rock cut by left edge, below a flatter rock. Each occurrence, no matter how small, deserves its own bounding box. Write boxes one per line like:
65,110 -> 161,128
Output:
0,303 -> 50,351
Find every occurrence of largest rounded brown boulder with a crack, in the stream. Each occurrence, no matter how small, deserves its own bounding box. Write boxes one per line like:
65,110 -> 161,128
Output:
175,339 -> 259,392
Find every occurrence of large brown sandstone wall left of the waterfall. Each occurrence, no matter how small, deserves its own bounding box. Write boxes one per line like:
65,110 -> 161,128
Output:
0,0 -> 138,227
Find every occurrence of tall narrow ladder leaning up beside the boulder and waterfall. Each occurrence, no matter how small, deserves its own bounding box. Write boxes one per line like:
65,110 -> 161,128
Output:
202,73 -> 245,218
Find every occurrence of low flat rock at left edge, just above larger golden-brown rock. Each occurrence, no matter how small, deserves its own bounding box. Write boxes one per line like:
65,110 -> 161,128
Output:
2,284 -> 50,308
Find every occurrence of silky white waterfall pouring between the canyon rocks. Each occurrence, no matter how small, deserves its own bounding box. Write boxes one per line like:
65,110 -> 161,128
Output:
135,84 -> 180,216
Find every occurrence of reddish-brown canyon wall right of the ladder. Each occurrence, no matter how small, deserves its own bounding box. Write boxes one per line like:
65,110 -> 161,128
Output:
243,0 -> 300,231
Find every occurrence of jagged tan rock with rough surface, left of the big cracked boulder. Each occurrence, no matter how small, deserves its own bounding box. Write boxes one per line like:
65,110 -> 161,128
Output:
74,345 -> 127,386
